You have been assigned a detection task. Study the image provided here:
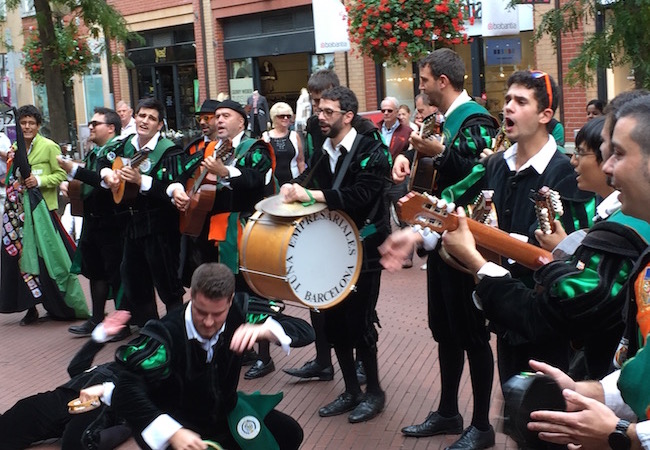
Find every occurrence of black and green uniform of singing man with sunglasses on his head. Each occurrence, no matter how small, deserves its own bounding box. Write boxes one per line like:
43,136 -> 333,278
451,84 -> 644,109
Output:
442,144 -> 595,383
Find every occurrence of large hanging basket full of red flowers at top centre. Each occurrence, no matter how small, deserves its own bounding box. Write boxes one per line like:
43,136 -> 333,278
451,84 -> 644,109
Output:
347,0 -> 473,64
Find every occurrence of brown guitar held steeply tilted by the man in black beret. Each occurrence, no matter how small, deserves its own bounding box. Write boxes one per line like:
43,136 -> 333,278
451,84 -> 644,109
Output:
179,139 -> 233,237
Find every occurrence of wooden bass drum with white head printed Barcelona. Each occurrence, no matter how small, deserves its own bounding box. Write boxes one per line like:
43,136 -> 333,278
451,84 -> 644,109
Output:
240,209 -> 363,309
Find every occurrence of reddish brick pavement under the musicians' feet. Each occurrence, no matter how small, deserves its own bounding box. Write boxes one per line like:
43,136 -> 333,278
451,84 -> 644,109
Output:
0,255 -> 516,450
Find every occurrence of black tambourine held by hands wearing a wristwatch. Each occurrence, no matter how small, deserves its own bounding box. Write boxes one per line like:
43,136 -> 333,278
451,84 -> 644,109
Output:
503,372 -> 566,449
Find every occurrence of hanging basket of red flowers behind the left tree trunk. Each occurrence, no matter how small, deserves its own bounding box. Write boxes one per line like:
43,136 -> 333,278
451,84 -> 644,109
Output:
23,24 -> 93,84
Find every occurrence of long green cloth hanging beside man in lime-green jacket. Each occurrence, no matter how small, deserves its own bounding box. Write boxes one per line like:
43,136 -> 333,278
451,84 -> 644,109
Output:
19,193 -> 89,319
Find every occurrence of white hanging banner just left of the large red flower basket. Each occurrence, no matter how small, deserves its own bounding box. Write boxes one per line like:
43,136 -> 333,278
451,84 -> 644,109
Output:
312,0 -> 350,53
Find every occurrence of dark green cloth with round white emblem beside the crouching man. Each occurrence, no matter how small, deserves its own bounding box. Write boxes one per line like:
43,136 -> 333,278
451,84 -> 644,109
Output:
228,391 -> 284,450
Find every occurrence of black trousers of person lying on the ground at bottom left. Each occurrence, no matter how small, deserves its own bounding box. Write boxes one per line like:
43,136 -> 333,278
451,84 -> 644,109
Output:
0,387 -> 103,450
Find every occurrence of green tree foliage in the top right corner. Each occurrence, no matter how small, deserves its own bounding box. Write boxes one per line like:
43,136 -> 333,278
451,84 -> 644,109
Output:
534,0 -> 650,88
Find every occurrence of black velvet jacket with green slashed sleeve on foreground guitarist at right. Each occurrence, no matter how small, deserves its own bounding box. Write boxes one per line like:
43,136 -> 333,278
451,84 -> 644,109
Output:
476,212 -> 650,380
